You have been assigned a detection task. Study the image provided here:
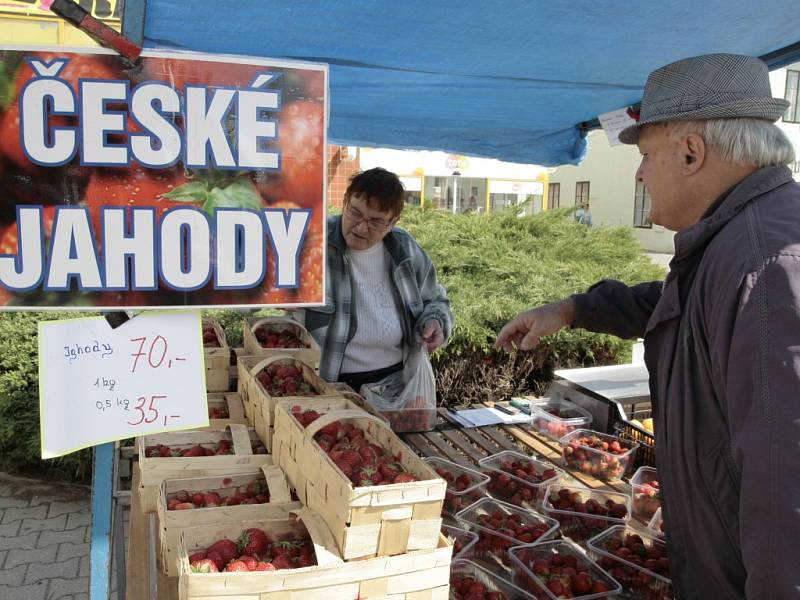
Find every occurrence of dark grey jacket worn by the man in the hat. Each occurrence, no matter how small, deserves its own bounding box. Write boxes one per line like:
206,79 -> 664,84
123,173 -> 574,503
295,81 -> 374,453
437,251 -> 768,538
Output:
574,167 -> 800,600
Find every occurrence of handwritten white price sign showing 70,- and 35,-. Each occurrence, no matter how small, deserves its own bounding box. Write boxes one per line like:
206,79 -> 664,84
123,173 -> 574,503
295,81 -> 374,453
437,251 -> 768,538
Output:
39,311 -> 208,458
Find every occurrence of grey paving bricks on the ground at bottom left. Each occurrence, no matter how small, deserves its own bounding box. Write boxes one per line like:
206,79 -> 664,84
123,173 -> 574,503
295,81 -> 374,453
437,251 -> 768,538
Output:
0,473 -> 123,600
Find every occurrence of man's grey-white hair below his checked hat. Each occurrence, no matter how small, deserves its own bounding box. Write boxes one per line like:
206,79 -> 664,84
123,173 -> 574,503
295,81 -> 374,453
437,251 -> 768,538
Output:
670,118 -> 795,169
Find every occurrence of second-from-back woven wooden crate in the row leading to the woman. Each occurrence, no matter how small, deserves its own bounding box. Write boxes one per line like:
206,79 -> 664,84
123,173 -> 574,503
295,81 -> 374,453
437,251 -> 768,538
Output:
239,355 -> 341,451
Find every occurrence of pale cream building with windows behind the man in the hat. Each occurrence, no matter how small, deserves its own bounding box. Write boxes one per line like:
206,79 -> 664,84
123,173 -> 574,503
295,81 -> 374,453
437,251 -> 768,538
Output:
549,62 -> 800,253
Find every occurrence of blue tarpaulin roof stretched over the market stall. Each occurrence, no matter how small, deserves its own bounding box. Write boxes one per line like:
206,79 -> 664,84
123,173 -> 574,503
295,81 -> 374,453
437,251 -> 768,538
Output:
144,0 -> 800,165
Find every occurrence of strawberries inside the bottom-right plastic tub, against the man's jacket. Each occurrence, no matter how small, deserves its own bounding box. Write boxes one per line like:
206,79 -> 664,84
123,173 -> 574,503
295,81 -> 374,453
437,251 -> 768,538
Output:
597,533 -> 671,600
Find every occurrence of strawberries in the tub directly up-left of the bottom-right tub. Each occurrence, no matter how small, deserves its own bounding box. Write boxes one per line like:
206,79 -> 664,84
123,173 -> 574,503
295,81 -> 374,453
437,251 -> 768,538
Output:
544,488 -> 628,542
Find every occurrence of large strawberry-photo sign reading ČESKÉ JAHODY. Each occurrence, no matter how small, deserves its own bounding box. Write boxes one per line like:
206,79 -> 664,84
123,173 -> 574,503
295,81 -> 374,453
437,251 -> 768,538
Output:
0,50 -> 327,308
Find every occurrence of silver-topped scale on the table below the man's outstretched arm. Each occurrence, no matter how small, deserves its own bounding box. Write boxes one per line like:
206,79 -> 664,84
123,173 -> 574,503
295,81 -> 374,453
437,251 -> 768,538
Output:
545,363 -> 651,433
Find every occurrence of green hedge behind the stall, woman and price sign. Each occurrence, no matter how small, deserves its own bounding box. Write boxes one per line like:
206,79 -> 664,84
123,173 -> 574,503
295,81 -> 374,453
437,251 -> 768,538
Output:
0,208 -> 663,481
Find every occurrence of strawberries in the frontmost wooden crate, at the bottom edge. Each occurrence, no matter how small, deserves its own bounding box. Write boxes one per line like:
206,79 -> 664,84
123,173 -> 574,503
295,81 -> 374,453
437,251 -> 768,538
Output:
189,527 -> 317,573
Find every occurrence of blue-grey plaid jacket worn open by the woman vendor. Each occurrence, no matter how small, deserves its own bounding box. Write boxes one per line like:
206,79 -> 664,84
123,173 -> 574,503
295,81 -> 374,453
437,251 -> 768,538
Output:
305,216 -> 453,381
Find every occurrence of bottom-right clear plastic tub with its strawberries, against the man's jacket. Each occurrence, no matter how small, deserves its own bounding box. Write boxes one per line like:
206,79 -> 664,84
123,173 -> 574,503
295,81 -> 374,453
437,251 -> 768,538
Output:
588,526 -> 673,600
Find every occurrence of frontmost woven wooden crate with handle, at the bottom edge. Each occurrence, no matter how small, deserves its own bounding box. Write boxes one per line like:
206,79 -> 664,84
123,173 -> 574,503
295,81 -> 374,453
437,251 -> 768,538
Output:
179,509 -> 453,600
